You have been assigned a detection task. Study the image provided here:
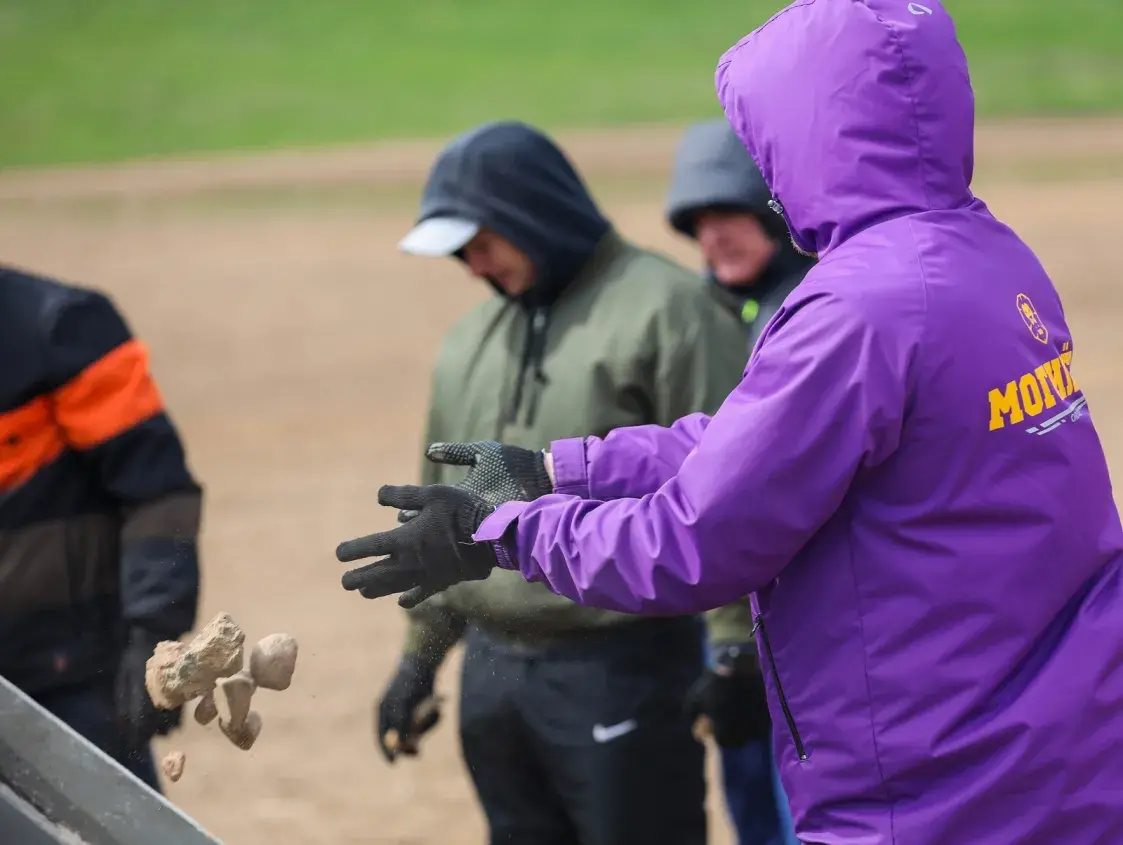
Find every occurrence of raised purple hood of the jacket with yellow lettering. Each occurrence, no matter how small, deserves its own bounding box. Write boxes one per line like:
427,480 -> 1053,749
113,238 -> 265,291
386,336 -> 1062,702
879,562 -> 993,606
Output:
715,0 -> 975,257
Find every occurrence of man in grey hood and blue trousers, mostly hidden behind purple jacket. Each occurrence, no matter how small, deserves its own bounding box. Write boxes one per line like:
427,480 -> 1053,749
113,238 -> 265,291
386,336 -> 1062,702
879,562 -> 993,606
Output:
667,118 -> 814,845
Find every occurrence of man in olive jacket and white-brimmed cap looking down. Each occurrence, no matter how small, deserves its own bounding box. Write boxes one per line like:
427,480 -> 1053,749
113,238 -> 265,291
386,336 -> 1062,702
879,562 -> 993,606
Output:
377,122 -> 754,845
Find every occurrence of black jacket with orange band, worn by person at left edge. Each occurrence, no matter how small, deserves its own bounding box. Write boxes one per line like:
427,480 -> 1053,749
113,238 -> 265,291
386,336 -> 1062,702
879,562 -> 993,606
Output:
0,266 -> 202,694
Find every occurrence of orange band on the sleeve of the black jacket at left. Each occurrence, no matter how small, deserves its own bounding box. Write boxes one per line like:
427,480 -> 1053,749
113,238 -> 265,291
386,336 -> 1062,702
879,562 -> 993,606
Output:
51,339 -> 164,449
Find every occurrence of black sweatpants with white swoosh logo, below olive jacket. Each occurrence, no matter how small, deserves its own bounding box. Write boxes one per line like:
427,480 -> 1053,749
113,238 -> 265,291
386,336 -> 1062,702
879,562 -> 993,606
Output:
460,618 -> 706,845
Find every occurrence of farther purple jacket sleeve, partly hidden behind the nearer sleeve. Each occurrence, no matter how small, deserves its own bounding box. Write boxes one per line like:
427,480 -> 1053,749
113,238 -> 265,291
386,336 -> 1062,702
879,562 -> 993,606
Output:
550,414 -> 710,500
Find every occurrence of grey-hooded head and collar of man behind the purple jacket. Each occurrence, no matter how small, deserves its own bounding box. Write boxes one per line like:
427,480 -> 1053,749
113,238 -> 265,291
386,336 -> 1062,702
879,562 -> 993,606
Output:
667,118 -> 815,348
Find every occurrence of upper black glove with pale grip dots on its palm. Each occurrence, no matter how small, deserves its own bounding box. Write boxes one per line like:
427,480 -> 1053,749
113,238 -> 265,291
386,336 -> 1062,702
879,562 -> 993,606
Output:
398,440 -> 554,523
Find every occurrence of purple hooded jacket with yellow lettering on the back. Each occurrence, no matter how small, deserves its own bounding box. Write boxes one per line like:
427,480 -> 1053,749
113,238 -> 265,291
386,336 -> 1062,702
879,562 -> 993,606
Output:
476,0 -> 1123,845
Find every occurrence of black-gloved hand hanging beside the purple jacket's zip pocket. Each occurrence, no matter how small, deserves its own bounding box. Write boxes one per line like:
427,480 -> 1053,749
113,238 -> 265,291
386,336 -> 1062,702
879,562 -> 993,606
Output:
686,643 -> 772,748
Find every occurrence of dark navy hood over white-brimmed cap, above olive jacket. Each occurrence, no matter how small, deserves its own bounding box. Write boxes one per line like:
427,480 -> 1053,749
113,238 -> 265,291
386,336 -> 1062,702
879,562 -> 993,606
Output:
402,120 -> 611,308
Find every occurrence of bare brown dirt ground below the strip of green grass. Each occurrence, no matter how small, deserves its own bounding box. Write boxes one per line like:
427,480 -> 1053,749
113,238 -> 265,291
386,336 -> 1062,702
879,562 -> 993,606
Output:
0,121 -> 1123,845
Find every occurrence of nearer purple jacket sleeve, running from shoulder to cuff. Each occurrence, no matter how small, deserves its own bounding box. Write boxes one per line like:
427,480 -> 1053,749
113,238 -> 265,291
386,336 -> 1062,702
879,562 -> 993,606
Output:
475,292 -> 911,614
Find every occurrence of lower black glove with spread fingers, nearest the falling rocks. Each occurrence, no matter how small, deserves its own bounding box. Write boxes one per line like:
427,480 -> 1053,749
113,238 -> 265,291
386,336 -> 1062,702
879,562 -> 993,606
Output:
336,484 -> 496,608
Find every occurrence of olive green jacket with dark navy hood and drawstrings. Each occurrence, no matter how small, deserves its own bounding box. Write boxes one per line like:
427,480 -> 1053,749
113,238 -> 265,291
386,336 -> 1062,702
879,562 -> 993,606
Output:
405,124 -> 751,663
